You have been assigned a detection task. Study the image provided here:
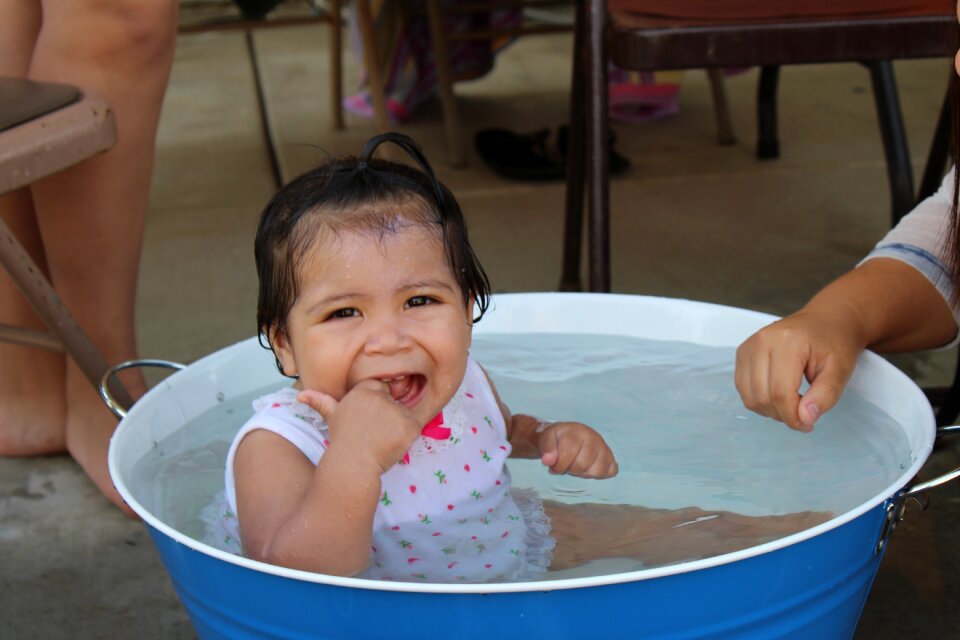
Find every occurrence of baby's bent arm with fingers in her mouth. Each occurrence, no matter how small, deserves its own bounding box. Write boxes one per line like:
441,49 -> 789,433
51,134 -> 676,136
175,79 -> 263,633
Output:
234,382 -> 419,575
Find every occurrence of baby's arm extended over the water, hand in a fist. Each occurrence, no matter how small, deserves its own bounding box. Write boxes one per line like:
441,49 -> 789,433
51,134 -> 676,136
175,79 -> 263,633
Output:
487,368 -> 618,478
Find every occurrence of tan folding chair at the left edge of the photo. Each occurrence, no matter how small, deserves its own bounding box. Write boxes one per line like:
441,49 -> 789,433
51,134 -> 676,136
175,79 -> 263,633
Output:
0,77 -> 132,406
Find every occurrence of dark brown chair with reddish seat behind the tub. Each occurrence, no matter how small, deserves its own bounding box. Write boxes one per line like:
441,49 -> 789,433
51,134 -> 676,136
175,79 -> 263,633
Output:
560,0 -> 957,291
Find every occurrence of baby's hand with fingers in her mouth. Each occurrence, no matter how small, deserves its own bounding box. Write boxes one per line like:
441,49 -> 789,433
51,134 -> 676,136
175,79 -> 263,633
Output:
297,380 -> 423,473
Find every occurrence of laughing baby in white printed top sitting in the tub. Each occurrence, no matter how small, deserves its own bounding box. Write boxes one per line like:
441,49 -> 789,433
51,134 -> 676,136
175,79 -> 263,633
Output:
210,133 -> 822,582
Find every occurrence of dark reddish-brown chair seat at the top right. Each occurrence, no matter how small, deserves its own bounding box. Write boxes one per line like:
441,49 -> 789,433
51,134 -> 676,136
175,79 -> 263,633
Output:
607,0 -> 957,70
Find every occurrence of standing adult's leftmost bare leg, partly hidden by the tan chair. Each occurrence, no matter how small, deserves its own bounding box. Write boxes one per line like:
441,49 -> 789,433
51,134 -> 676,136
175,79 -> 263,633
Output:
0,0 -> 66,456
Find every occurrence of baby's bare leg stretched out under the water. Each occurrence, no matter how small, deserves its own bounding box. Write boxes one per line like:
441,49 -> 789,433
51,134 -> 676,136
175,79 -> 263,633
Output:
543,501 -> 830,570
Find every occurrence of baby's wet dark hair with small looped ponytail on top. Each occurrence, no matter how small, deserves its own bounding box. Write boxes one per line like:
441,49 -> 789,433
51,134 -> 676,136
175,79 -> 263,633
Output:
254,132 -> 490,358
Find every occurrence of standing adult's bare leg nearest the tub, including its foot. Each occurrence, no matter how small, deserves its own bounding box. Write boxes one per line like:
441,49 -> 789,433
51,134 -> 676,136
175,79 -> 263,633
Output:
4,0 -> 177,504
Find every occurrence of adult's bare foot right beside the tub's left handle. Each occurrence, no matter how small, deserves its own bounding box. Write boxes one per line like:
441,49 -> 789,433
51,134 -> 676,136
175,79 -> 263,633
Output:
66,365 -> 143,518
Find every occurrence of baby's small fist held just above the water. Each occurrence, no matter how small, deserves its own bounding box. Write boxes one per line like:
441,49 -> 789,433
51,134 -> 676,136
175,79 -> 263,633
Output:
538,422 -> 619,478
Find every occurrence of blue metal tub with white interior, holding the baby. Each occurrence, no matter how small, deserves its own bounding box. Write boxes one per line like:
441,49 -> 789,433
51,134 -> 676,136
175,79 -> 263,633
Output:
109,293 -> 952,640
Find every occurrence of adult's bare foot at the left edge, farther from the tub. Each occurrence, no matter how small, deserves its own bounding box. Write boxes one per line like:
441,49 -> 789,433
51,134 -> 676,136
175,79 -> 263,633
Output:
0,344 -> 67,456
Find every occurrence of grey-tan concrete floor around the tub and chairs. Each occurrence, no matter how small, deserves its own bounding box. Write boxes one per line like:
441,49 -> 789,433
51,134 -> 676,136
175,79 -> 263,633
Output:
0,15 -> 960,639
